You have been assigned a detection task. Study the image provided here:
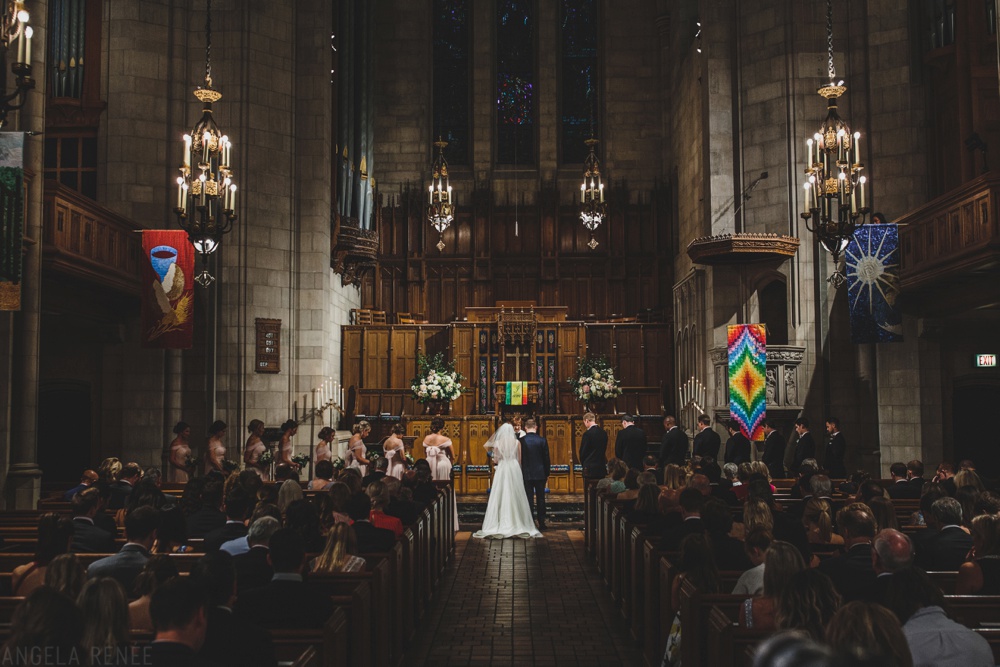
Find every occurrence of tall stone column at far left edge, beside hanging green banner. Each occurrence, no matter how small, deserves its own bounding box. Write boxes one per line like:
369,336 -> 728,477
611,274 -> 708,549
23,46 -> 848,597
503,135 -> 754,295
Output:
4,0 -> 48,509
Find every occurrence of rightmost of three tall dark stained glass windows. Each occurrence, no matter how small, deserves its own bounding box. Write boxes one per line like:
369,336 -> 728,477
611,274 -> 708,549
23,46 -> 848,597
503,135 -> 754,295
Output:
559,0 -> 599,164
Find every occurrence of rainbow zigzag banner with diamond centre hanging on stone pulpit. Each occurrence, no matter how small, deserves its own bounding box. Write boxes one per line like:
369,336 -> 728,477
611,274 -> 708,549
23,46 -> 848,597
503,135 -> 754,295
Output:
729,324 -> 767,440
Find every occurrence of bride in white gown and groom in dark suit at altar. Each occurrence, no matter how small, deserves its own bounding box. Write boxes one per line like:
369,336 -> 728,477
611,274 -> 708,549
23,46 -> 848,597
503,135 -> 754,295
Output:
473,419 -> 551,539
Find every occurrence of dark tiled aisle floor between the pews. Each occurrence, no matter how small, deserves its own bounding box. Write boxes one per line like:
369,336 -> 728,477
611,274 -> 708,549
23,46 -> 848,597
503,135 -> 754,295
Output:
403,529 -> 641,667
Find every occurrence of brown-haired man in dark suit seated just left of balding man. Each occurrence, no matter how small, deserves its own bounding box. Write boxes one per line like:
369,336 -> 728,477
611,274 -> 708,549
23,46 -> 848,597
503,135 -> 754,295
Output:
818,503 -> 877,602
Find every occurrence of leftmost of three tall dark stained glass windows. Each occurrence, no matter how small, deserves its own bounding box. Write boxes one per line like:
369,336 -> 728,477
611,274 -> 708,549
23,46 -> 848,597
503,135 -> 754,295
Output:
433,0 -> 472,164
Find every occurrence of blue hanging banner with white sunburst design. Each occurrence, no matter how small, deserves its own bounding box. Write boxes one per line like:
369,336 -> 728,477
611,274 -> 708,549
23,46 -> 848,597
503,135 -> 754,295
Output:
846,224 -> 903,343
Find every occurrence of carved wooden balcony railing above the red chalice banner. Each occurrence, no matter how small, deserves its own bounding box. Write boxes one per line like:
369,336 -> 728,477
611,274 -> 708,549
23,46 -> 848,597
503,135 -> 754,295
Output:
42,181 -> 142,294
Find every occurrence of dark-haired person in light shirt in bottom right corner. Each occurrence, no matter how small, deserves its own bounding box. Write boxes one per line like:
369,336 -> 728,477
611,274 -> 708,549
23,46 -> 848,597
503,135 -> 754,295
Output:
886,568 -> 995,667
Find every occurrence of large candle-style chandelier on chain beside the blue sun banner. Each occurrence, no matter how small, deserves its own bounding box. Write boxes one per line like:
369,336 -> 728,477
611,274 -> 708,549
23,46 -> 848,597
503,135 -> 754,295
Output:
801,0 -> 871,288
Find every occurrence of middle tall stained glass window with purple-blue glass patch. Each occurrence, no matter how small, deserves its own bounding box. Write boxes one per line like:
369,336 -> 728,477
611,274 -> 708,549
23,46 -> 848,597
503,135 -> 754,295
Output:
496,0 -> 536,165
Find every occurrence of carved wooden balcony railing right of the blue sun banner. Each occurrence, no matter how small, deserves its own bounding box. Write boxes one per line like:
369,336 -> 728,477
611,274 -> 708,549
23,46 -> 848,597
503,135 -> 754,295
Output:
898,171 -> 1000,298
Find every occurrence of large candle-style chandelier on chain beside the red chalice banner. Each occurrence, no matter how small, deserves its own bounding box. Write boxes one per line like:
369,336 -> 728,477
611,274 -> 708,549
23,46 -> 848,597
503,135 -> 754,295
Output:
174,0 -> 237,287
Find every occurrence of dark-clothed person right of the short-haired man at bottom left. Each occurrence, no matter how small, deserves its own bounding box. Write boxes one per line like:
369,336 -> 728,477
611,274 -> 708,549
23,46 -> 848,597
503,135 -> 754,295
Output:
191,551 -> 278,667
